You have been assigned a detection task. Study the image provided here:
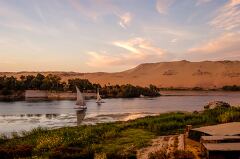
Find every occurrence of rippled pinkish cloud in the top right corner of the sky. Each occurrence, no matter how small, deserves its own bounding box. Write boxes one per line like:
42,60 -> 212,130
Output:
210,0 -> 240,30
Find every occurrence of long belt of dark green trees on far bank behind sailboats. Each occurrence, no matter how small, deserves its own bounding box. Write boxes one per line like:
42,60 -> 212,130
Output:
0,74 -> 160,98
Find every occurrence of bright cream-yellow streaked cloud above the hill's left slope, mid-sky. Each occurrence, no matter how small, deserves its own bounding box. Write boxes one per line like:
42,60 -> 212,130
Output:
87,38 -> 166,67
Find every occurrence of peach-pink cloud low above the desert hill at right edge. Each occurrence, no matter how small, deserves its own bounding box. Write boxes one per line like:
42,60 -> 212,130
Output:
189,33 -> 240,59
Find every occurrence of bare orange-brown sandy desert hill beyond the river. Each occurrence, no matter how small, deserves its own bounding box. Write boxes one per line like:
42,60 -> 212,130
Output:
0,61 -> 240,88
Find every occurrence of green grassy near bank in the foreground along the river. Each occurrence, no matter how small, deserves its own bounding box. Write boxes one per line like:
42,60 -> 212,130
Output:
0,107 -> 240,159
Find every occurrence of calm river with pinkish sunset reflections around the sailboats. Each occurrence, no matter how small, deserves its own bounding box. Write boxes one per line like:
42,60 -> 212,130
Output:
0,91 -> 240,134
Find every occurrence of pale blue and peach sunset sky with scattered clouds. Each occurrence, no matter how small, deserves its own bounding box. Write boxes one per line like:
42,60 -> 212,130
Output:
0,0 -> 240,72
